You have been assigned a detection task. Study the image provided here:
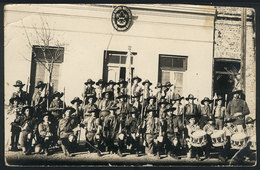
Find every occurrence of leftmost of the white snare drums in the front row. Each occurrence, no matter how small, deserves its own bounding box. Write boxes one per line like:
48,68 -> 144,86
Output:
190,130 -> 207,147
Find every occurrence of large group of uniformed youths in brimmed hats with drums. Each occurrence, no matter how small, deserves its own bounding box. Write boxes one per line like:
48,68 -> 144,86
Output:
6,77 -> 256,162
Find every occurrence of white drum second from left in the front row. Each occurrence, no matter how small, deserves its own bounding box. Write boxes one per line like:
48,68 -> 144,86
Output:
210,130 -> 227,147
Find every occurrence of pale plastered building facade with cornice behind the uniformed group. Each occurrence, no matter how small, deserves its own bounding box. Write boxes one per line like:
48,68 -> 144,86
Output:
4,4 -> 255,117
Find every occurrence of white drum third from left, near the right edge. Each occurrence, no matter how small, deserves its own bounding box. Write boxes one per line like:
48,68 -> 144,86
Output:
230,133 -> 248,149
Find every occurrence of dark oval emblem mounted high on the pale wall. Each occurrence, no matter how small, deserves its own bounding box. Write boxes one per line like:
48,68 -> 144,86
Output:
111,6 -> 133,31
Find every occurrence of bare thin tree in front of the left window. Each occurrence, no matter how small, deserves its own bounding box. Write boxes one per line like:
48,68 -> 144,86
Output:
23,16 -> 65,107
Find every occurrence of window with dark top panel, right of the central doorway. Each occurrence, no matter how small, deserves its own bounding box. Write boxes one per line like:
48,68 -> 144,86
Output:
158,55 -> 188,95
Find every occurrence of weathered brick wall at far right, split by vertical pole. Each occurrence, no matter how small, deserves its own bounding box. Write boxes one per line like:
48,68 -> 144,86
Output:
214,7 -> 256,117
